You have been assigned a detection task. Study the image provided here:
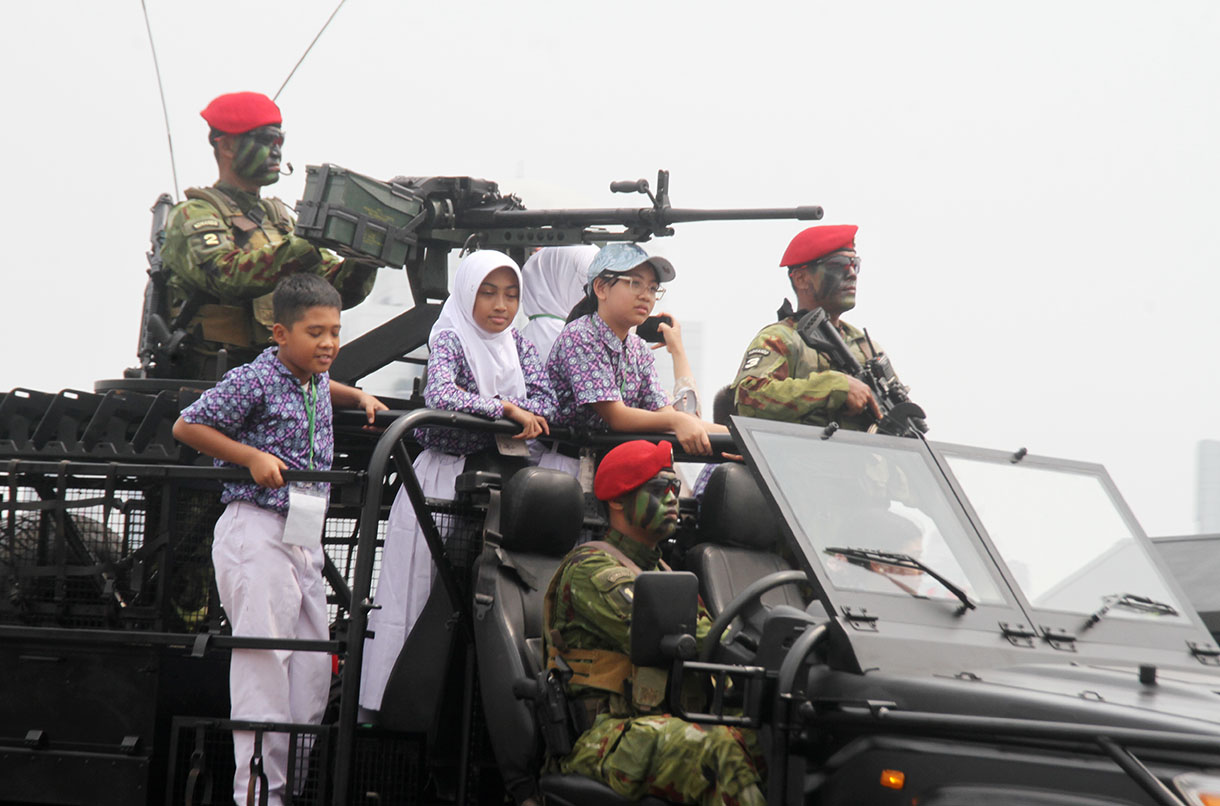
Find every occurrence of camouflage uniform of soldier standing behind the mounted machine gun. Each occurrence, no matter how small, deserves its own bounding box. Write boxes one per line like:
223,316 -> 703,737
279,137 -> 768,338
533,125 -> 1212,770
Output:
161,183 -> 376,379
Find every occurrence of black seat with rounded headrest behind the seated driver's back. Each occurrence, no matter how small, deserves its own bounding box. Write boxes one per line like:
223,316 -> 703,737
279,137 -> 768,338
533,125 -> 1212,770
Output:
475,467 -> 662,806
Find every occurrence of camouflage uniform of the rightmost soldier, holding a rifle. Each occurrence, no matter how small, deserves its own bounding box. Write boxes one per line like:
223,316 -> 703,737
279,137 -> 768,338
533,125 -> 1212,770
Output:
733,315 -> 883,430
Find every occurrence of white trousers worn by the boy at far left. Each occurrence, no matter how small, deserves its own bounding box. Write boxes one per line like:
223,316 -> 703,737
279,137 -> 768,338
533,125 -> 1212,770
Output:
212,501 -> 331,806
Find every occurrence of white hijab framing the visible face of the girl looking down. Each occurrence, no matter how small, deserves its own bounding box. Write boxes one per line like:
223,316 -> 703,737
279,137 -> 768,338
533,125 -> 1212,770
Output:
428,249 -> 526,398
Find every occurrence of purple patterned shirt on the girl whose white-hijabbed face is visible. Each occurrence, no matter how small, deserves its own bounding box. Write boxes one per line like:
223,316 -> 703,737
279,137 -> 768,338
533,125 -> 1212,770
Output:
415,329 -> 555,456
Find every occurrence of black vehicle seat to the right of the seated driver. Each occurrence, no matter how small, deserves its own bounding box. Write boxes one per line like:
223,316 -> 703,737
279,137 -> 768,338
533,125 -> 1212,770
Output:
684,462 -> 805,618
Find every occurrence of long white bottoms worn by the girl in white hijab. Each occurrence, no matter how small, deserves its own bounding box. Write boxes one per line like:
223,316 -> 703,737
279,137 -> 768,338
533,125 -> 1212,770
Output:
360,449 -> 466,711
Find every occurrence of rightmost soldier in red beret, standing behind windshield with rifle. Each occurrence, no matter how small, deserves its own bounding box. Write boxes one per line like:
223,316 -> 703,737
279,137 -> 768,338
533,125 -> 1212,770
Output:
733,224 -> 912,430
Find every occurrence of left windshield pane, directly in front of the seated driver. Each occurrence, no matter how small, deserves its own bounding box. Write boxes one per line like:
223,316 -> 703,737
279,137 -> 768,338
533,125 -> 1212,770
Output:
754,430 -> 1003,604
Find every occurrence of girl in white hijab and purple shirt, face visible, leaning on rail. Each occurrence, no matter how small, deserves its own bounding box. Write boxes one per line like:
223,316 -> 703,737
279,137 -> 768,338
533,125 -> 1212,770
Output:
360,250 -> 555,711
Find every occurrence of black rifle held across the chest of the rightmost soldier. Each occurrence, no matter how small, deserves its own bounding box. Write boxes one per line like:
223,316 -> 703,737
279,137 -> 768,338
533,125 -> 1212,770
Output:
797,307 -> 927,437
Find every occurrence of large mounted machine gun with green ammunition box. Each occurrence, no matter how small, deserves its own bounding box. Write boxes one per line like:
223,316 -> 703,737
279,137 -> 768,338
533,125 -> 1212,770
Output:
296,165 -> 822,383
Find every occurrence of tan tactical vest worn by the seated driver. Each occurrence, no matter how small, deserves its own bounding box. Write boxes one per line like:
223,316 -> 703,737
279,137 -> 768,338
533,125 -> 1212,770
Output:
543,540 -> 697,723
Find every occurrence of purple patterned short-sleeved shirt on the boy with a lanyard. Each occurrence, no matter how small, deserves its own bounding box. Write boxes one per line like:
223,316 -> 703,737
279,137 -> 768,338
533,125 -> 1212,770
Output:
182,348 -> 334,515
